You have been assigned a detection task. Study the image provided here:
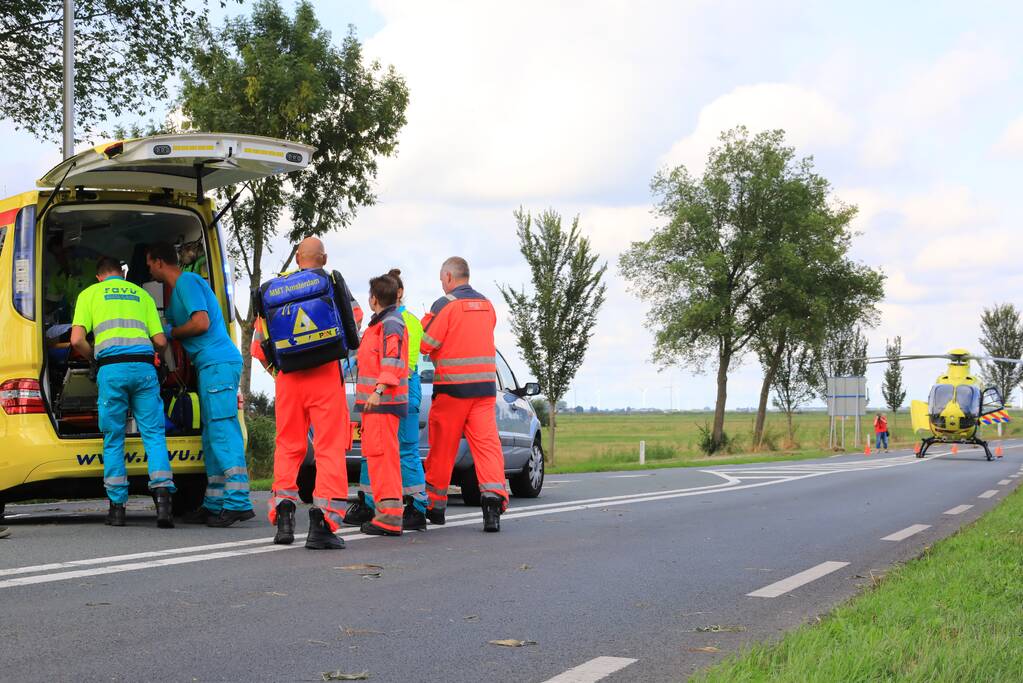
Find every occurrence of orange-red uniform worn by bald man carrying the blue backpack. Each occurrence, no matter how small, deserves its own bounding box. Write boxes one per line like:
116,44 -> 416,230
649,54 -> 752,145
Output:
250,302 -> 362,532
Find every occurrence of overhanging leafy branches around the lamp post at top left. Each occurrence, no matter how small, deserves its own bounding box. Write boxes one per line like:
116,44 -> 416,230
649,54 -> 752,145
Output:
0,0 -> 232,142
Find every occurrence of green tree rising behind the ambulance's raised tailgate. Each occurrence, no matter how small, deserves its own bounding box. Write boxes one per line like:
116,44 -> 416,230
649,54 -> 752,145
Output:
181,0 -> 408,395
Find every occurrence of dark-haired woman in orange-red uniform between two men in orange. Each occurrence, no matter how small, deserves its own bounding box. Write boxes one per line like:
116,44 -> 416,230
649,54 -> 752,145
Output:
355,275 -> 408,536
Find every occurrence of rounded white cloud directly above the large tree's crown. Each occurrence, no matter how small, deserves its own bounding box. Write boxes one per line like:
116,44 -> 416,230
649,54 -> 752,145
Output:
662,83 -> 852,173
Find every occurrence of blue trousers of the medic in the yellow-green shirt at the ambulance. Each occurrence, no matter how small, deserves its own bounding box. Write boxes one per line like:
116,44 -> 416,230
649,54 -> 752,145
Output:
96,363 -> 176,505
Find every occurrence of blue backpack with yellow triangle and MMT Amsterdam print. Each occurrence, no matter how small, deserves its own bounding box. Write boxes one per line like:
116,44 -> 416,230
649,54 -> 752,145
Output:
255,268 -> 359,372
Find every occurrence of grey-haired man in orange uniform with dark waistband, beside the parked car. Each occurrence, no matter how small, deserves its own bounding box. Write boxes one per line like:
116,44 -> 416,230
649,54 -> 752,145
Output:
421,257 -> 508,532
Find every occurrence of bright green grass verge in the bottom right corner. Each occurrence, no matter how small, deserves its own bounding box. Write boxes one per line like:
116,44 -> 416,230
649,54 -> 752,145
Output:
691,484 -> 1023,683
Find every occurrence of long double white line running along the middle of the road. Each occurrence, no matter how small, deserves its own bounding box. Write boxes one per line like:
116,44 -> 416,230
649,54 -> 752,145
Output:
0,447 -> 969,589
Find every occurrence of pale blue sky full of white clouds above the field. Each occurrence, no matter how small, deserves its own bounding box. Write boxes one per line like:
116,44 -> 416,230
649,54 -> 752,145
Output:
0,0 -> 1023,408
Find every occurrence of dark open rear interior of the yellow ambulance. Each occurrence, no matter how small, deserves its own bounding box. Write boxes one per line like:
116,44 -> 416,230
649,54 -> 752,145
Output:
41,202 -> 210,437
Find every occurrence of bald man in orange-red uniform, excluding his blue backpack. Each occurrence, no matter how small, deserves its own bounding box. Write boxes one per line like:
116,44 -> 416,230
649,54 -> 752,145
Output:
251,237 -> 362,550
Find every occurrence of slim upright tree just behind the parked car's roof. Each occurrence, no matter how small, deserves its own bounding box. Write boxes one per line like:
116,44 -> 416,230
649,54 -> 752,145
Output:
500,209 -> 608,465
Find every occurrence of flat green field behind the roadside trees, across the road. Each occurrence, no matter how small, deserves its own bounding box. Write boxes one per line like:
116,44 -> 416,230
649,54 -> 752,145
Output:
543,411 -> 1023,469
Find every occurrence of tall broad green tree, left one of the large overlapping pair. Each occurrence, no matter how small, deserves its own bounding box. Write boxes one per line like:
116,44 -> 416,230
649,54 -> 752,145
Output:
620,127 -> 867,451
